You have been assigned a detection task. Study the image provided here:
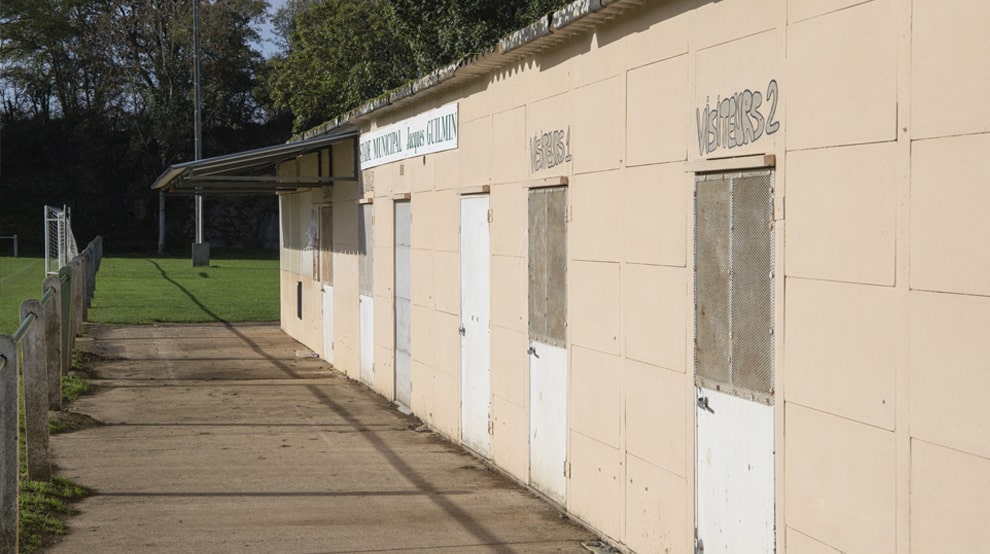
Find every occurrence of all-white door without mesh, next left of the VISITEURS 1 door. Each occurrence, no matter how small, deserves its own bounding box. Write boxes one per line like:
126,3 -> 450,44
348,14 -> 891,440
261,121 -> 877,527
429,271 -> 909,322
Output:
459,195 -> 491,457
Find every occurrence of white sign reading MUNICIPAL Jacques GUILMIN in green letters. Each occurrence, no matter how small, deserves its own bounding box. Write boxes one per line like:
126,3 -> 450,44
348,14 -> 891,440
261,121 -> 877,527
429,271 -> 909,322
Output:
360,102 -> 457,169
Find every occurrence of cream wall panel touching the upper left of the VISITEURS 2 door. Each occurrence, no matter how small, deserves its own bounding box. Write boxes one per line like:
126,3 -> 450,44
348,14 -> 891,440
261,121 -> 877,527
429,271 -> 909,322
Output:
620,163 -> 693,267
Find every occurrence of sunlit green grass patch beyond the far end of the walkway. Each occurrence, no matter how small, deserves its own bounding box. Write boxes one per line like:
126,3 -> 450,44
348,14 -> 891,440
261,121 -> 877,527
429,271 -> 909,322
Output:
88,258 -> 279,324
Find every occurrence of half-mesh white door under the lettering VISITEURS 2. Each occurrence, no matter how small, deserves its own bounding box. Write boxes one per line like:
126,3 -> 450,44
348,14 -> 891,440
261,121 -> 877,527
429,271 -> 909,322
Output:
694,170 -> 775,554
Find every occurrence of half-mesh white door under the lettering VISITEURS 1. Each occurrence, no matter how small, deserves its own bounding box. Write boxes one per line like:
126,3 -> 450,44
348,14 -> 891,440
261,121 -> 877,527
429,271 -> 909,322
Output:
529,187 -> 567,504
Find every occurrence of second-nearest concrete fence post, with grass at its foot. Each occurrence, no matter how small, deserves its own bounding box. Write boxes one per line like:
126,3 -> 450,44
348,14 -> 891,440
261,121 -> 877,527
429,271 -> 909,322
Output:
20,300 -> 52,482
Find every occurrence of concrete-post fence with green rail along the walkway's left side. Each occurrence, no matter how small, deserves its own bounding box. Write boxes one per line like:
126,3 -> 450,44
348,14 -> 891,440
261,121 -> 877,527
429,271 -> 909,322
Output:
0,237 -> 103,554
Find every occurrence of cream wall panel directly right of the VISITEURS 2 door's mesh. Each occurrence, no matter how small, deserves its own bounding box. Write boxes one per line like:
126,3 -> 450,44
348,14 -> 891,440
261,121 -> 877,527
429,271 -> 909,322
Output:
786,142 -> 897,285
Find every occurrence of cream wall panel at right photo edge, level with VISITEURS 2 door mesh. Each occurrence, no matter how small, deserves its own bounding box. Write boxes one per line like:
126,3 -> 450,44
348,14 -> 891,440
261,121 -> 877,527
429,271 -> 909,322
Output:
911,135 -> 990,296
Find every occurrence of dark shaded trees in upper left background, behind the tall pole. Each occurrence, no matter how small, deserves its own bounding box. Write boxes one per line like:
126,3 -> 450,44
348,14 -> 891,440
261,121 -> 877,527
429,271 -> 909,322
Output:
0,0 -> 288,249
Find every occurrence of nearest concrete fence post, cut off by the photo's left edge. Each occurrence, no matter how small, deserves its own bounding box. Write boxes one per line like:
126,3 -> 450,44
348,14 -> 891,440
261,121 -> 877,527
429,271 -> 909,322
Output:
0,335 -> 18,554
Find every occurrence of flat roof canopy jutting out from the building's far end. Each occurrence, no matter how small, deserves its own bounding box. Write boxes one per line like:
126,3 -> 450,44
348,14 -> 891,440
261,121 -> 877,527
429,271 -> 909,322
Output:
151,129 -> 358,196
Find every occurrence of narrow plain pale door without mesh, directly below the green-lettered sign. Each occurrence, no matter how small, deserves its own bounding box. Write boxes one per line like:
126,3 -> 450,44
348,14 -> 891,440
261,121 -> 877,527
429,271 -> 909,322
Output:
395,201 -> 412,407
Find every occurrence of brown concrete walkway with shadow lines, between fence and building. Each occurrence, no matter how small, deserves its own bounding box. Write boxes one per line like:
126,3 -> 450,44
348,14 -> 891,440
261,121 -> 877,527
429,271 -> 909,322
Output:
49,324 -> 594,553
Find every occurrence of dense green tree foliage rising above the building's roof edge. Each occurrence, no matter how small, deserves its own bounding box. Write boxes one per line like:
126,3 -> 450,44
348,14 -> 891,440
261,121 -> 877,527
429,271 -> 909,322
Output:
270,0 -> 569,131
